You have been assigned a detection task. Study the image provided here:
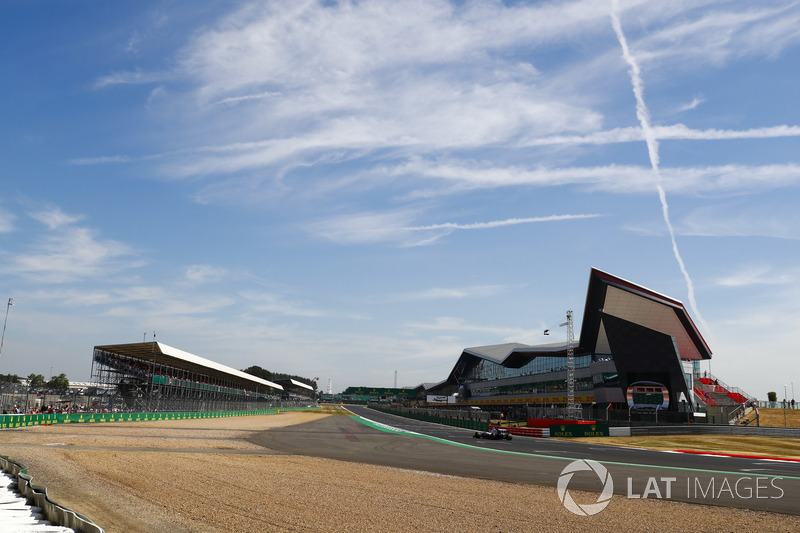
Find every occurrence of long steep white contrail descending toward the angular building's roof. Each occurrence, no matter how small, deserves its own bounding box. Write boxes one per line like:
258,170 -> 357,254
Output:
611,0 -> 710,333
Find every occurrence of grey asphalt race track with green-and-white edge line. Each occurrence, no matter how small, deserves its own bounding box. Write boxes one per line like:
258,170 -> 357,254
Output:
250,406 -> 800,515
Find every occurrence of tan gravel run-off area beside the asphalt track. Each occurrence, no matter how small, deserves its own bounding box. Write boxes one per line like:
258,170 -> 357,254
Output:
0,412 -> 800,533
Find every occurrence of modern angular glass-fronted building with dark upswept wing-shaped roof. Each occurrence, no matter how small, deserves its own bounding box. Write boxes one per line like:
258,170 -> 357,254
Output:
420,268 -> 711,413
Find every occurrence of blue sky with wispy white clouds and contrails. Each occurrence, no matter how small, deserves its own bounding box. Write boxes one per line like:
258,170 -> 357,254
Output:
0,0 -> 800,399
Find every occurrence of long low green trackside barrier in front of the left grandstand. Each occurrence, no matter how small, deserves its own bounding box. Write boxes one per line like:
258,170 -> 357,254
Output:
0,407 -> 318,429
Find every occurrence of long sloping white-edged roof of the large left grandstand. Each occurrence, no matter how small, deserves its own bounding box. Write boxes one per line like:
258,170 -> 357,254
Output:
94,342 -> 283,390
